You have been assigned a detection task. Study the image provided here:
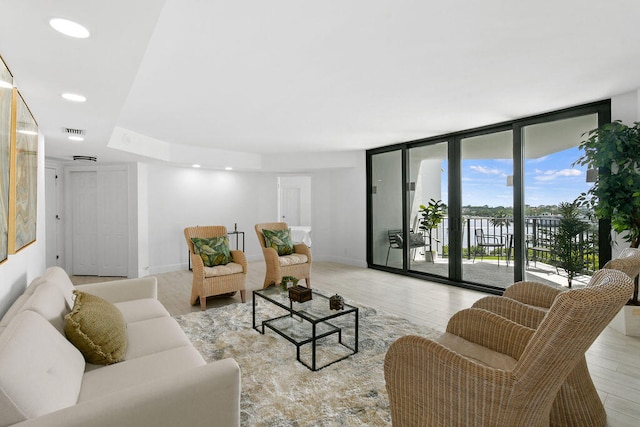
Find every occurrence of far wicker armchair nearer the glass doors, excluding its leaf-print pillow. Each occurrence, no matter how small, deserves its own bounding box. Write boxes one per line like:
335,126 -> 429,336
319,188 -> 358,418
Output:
255,222 -> 311,288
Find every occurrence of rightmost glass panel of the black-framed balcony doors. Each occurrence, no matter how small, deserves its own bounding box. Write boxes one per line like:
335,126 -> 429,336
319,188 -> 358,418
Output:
523,114 -> 599,286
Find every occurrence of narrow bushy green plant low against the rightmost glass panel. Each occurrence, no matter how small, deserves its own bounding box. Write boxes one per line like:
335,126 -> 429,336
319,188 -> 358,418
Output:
551,202 -> 591,287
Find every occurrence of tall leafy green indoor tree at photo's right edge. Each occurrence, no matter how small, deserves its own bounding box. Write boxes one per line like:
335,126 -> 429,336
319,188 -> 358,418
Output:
575,120 -> 640,305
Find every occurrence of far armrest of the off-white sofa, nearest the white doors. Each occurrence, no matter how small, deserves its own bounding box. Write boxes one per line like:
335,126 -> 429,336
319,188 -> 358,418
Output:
76,276 -> 158,303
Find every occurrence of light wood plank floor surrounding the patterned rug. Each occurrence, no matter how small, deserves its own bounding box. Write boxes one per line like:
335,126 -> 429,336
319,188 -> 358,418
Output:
74,262 -> 640,427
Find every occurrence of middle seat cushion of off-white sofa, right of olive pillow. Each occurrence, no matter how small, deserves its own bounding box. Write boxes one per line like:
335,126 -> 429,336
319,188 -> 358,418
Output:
125,317 -> 191,360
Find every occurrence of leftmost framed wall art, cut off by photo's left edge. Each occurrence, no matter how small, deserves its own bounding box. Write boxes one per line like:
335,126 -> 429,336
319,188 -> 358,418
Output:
0,58 -> 13,262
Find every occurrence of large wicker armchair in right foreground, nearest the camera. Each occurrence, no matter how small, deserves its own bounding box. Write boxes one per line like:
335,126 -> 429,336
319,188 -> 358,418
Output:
384,271 -> 633,426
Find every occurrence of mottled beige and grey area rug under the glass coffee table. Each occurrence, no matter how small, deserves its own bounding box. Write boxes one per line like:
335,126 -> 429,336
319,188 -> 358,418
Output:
176,290 -> 437,427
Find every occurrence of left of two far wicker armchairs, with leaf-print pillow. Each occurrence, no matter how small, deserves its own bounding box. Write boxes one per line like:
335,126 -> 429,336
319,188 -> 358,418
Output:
184,225 -> 247,310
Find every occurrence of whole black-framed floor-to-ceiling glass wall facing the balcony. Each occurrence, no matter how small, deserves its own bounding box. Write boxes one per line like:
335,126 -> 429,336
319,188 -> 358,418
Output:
367,101 -> 611,293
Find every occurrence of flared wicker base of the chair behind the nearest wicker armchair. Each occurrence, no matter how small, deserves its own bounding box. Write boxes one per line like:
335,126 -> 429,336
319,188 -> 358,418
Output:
550,357 -> 607,427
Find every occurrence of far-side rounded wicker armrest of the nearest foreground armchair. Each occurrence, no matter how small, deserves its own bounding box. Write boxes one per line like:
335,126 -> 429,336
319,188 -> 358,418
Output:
447,308 -> 535,360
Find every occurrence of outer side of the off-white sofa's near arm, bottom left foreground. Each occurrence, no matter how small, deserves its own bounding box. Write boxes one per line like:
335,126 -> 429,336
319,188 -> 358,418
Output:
16,359 -> 240,427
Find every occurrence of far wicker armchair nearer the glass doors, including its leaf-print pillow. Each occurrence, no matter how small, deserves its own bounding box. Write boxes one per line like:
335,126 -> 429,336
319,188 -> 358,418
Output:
255,222 -> 311,288
